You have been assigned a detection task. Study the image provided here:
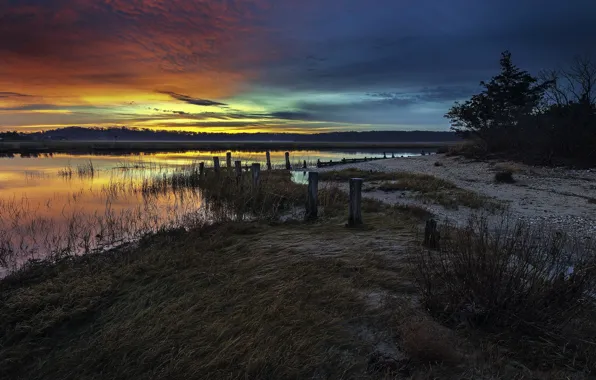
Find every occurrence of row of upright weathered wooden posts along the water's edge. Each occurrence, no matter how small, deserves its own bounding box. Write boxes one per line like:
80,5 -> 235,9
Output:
199,152 -> 364,227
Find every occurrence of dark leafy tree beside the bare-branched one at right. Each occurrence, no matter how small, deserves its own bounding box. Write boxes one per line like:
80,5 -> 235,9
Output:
445,51 -> 550,151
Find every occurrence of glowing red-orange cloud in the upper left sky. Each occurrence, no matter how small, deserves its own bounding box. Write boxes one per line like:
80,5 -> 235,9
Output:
0,0 -> 267,105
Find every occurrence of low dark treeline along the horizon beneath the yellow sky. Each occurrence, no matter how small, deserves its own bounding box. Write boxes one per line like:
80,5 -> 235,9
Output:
0,127 -> 459,142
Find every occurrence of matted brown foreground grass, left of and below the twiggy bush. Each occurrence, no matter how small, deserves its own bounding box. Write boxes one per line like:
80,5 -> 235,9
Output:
0,202 -> 596,380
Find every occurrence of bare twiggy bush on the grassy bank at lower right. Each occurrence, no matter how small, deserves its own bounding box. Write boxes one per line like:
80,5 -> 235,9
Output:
417,217 -> 596,332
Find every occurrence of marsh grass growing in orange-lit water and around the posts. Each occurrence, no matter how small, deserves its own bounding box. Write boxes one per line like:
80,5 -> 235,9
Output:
0,163 -> 347,270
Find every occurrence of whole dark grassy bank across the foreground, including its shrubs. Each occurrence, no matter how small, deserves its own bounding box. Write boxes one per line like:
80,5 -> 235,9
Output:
0,173 -> 596,379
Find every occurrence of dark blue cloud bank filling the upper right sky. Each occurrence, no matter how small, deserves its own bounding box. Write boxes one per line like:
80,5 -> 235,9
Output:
262,0 -> 596,91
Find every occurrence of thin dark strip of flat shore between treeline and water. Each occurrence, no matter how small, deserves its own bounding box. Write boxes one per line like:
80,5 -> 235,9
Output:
0,140 -> 459,154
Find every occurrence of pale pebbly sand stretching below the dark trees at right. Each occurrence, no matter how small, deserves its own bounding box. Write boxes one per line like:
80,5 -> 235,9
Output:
319,155 -> 596,237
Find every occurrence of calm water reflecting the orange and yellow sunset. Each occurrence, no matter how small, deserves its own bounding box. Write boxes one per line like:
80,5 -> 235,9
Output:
0,150 -> 428,274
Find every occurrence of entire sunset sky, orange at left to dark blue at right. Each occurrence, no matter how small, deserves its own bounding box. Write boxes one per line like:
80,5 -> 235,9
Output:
0,0 -> 596,133
